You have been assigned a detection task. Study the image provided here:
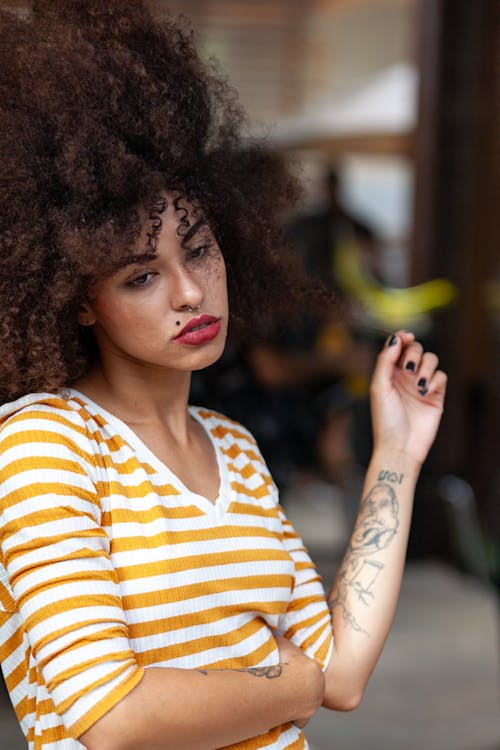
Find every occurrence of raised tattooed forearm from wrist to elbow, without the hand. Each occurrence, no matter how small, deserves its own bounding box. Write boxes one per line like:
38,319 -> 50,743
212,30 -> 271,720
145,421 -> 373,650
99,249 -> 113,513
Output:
324,450 -> 420,710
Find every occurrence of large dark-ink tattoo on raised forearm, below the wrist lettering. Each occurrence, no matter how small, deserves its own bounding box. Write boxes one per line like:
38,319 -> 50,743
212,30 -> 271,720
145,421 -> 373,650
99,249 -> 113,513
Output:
328,484 -> 403,635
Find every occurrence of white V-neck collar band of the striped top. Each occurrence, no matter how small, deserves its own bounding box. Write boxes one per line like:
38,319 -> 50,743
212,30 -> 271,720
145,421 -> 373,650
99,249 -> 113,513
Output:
64,388 -> 233,517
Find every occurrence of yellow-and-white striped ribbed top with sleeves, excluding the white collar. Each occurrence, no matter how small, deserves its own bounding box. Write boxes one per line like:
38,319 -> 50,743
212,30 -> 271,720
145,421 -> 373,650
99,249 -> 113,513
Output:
0,391 -> 332,750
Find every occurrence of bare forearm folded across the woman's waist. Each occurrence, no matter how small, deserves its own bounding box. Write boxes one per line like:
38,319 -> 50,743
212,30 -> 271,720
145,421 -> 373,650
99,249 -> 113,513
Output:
79,660 -> 323,750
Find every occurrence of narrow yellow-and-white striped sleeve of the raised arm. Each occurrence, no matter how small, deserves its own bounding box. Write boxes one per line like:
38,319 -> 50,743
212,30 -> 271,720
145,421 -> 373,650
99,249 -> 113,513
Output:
278,507 -> 333,670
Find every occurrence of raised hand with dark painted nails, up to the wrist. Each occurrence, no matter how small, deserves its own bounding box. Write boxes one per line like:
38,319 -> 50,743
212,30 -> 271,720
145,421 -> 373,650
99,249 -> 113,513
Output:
370,331 -> 447,464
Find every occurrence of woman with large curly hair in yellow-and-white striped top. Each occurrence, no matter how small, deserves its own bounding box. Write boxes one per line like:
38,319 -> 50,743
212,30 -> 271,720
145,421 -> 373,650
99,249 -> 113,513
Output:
0,0 -> 446,750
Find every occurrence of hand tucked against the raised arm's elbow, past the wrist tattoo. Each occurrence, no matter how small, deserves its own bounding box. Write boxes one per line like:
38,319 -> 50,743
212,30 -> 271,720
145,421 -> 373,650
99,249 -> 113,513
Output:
276,636 -> 325,729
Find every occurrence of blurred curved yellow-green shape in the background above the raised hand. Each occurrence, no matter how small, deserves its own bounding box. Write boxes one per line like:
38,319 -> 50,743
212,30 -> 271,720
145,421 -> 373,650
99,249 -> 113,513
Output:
333,242 -> 457,330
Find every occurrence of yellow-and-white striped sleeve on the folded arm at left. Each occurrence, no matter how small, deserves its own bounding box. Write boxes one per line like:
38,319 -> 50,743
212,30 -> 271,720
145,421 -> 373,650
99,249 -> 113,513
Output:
0,402 -> 143,738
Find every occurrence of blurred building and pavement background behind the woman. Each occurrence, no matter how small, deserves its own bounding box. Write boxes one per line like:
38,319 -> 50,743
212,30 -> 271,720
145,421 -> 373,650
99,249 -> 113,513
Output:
0,0 -> 500,750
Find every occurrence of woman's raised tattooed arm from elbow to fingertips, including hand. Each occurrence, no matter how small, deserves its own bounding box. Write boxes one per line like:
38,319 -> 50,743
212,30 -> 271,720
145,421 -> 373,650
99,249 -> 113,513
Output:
324,331 -> 446,711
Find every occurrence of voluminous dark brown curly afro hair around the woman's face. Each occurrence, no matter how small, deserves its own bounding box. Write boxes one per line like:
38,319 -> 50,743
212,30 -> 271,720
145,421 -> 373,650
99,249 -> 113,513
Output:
0,0 -> 332,400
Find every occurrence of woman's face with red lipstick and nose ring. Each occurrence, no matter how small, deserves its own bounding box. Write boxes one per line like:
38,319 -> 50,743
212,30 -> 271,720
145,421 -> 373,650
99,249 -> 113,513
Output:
81,194 -> 228,372
